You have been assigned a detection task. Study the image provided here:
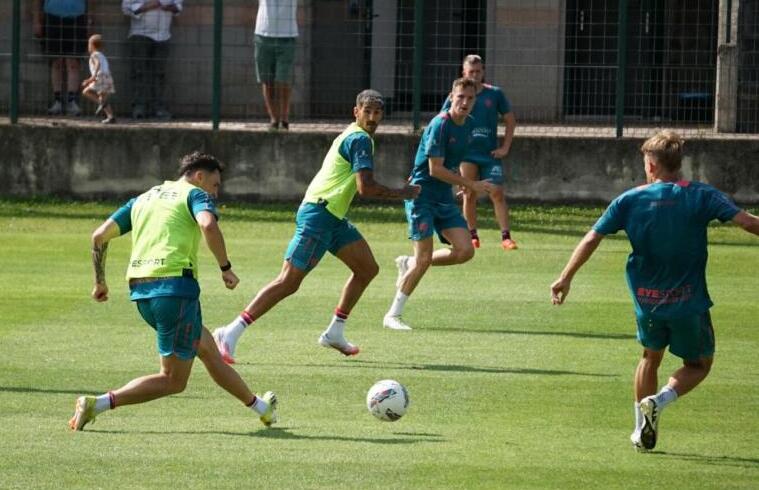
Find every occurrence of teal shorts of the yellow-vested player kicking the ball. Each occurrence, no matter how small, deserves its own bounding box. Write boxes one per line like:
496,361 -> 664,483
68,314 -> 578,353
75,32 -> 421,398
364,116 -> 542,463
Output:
137,296 -> 203,361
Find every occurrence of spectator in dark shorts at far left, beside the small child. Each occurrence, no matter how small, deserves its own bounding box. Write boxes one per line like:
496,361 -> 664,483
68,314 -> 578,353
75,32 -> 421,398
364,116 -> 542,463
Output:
33,0 -> 89,116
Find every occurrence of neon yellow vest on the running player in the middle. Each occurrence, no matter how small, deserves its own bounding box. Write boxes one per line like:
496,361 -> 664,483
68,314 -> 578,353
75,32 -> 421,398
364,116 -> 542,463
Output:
303,123 -> 374,219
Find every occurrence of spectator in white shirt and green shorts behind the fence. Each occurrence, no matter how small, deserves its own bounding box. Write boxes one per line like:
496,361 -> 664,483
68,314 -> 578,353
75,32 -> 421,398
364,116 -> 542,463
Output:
254,0 -> 298,131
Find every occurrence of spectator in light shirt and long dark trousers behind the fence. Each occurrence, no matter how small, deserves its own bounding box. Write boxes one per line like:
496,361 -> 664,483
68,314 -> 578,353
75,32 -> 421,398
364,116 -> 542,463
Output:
121,0 -> 183,119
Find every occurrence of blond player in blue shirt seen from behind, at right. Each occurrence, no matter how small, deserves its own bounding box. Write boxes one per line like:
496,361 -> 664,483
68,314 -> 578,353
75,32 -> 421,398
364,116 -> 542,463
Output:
551,131 -> 759,451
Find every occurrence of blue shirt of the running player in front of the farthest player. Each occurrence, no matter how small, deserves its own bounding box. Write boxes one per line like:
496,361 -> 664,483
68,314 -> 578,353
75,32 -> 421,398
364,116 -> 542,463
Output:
410,112 -> 472,202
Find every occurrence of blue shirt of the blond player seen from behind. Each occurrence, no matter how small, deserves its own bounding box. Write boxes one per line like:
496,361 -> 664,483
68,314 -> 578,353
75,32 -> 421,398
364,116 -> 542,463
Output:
593,181 -> 740,319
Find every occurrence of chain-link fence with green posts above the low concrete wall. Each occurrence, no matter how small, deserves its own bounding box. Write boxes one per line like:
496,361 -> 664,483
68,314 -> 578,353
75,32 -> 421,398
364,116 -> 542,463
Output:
0,0 -> 759,134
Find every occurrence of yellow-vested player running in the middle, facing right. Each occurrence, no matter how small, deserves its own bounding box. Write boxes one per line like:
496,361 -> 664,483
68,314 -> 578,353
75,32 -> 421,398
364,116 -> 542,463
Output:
213,90 -> 419,364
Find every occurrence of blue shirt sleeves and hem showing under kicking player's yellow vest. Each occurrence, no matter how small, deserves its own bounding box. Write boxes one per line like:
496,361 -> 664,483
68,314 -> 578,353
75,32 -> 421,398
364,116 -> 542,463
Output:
111,189 -> 219,301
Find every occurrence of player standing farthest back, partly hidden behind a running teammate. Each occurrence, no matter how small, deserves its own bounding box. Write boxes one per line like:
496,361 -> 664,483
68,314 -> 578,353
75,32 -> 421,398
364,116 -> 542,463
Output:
442,54 -> 517,251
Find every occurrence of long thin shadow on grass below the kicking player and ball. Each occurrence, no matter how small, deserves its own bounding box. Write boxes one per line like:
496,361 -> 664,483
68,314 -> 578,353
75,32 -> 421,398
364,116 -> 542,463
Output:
86,427 -> 445,445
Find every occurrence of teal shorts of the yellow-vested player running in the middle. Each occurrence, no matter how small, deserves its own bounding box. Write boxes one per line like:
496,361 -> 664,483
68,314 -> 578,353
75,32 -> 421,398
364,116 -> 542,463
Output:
285,202 -> 364,271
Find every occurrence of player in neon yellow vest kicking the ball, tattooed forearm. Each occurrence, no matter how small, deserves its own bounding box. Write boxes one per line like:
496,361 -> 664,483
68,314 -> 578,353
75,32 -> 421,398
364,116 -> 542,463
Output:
69,152 -> 277,430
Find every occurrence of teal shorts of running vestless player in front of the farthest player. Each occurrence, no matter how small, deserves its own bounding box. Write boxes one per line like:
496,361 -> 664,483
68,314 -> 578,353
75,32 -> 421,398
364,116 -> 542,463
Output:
405,199 -> 467,243
